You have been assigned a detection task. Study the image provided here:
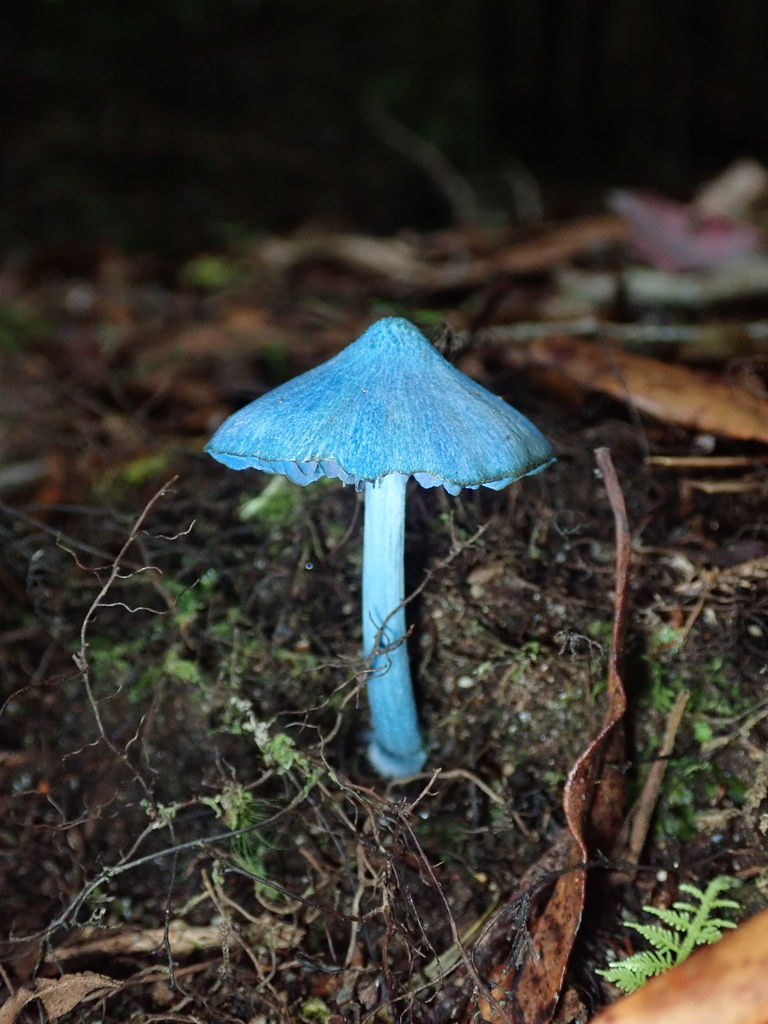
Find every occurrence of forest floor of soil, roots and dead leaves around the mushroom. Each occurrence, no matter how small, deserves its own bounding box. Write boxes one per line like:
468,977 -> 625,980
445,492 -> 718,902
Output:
0,209 -> 768,1024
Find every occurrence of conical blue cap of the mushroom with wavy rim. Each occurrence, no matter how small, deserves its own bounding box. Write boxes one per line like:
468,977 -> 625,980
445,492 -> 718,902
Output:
206,316 -> 555,494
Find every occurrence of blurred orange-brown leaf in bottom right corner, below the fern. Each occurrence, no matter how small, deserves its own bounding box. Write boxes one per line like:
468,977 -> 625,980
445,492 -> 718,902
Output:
592,910 -> 768,1024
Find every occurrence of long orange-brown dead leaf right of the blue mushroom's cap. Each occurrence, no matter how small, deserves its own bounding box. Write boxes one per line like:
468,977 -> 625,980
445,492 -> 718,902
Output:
529,337 -> 768,442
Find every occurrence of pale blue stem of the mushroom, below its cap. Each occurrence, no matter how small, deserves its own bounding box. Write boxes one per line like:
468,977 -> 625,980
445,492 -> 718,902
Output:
362,473 -> 427,778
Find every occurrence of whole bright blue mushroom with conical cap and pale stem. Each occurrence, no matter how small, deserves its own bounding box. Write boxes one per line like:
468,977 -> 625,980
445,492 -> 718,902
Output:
206,316 -> 554,778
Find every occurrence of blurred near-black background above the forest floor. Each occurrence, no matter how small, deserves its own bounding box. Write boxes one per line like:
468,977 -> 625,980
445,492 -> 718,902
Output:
6,0 -> 768,254
